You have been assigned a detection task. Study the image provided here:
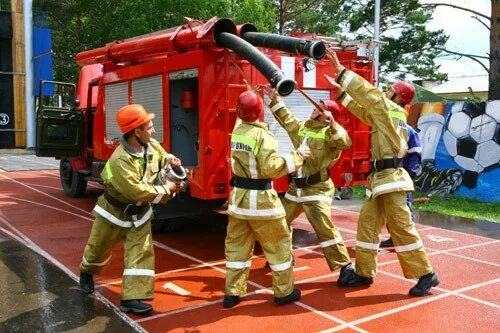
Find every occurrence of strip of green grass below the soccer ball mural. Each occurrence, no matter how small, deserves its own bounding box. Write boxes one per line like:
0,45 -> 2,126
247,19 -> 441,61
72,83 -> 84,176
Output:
353,186 -> 500,223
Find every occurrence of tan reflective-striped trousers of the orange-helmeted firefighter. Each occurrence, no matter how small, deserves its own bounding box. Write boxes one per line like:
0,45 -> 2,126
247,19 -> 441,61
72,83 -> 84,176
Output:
80,215 -> 154,300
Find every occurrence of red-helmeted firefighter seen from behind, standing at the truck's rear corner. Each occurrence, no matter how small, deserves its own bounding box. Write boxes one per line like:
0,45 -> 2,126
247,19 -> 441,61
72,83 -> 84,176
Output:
223,90 -> 310,308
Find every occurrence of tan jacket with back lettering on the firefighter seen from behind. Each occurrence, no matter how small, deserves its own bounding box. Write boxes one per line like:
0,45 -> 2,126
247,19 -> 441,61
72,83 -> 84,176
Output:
228,122 -> 303,220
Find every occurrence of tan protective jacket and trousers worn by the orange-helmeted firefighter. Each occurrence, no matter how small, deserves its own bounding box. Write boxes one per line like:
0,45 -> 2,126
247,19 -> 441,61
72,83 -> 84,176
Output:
80,137 -> 179,300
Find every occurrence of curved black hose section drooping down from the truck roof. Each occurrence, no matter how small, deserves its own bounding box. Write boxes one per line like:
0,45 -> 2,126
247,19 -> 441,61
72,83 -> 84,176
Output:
216,32 -> 295,96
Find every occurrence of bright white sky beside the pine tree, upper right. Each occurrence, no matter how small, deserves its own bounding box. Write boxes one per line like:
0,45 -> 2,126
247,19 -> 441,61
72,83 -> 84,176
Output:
420,0 -> 491,77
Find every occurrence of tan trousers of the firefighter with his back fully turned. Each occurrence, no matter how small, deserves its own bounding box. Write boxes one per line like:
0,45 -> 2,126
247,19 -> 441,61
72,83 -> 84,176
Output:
225,216 -> 293,297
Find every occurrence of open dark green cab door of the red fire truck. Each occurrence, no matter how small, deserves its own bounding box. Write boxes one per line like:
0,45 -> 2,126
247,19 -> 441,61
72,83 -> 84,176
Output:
36,80 -> 83,157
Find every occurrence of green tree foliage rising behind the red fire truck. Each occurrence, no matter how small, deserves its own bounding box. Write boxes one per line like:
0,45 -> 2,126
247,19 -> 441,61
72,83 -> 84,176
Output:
33,0 -> 500,98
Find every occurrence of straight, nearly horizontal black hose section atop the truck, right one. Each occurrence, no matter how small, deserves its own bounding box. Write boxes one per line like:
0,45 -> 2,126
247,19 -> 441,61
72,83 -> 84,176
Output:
241,31 -> 326,60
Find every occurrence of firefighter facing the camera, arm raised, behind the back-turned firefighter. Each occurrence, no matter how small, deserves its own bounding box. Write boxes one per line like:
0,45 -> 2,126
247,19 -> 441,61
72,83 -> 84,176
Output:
266,88 -> 354,285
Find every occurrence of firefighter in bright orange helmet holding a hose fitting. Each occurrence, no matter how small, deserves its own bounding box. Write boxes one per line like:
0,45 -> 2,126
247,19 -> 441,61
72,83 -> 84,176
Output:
80,104 -> 181,313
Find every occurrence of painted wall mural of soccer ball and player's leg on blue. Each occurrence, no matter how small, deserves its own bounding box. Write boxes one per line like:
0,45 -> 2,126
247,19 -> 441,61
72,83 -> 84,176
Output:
408,101 -> 500,202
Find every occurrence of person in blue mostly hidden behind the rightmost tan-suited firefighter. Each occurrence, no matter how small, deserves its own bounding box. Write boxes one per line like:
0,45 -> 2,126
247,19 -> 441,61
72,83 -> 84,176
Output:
380,125 -> 422,247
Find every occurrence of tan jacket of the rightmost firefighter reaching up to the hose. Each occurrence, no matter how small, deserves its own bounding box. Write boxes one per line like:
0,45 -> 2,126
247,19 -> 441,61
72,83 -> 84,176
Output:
337,69 -> 414,197
